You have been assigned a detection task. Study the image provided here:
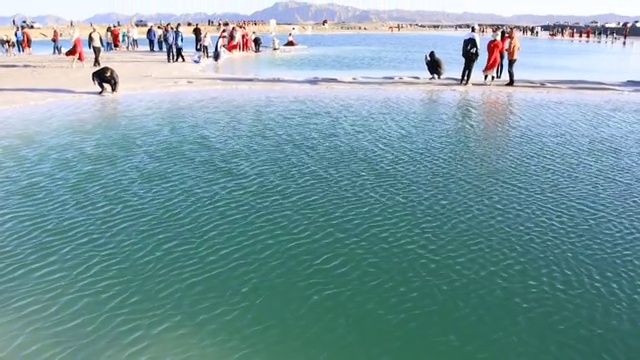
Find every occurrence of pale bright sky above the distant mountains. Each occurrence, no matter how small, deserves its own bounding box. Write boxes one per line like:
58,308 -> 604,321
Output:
0,0 -> 640,20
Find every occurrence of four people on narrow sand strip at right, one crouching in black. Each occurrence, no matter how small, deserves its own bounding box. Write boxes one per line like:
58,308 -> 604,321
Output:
425,25 -> 520,86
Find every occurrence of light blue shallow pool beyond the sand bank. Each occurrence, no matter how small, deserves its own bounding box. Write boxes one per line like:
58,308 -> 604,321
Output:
27,31 -> 640,81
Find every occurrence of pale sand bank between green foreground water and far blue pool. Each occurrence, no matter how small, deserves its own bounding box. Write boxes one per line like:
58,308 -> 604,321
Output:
0,52 -> 640,108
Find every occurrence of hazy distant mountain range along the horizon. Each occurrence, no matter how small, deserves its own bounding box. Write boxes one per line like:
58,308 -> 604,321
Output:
0,1 -> 640,25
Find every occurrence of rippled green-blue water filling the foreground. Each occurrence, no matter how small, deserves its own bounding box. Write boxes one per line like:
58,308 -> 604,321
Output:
0,89 -> 640,360
